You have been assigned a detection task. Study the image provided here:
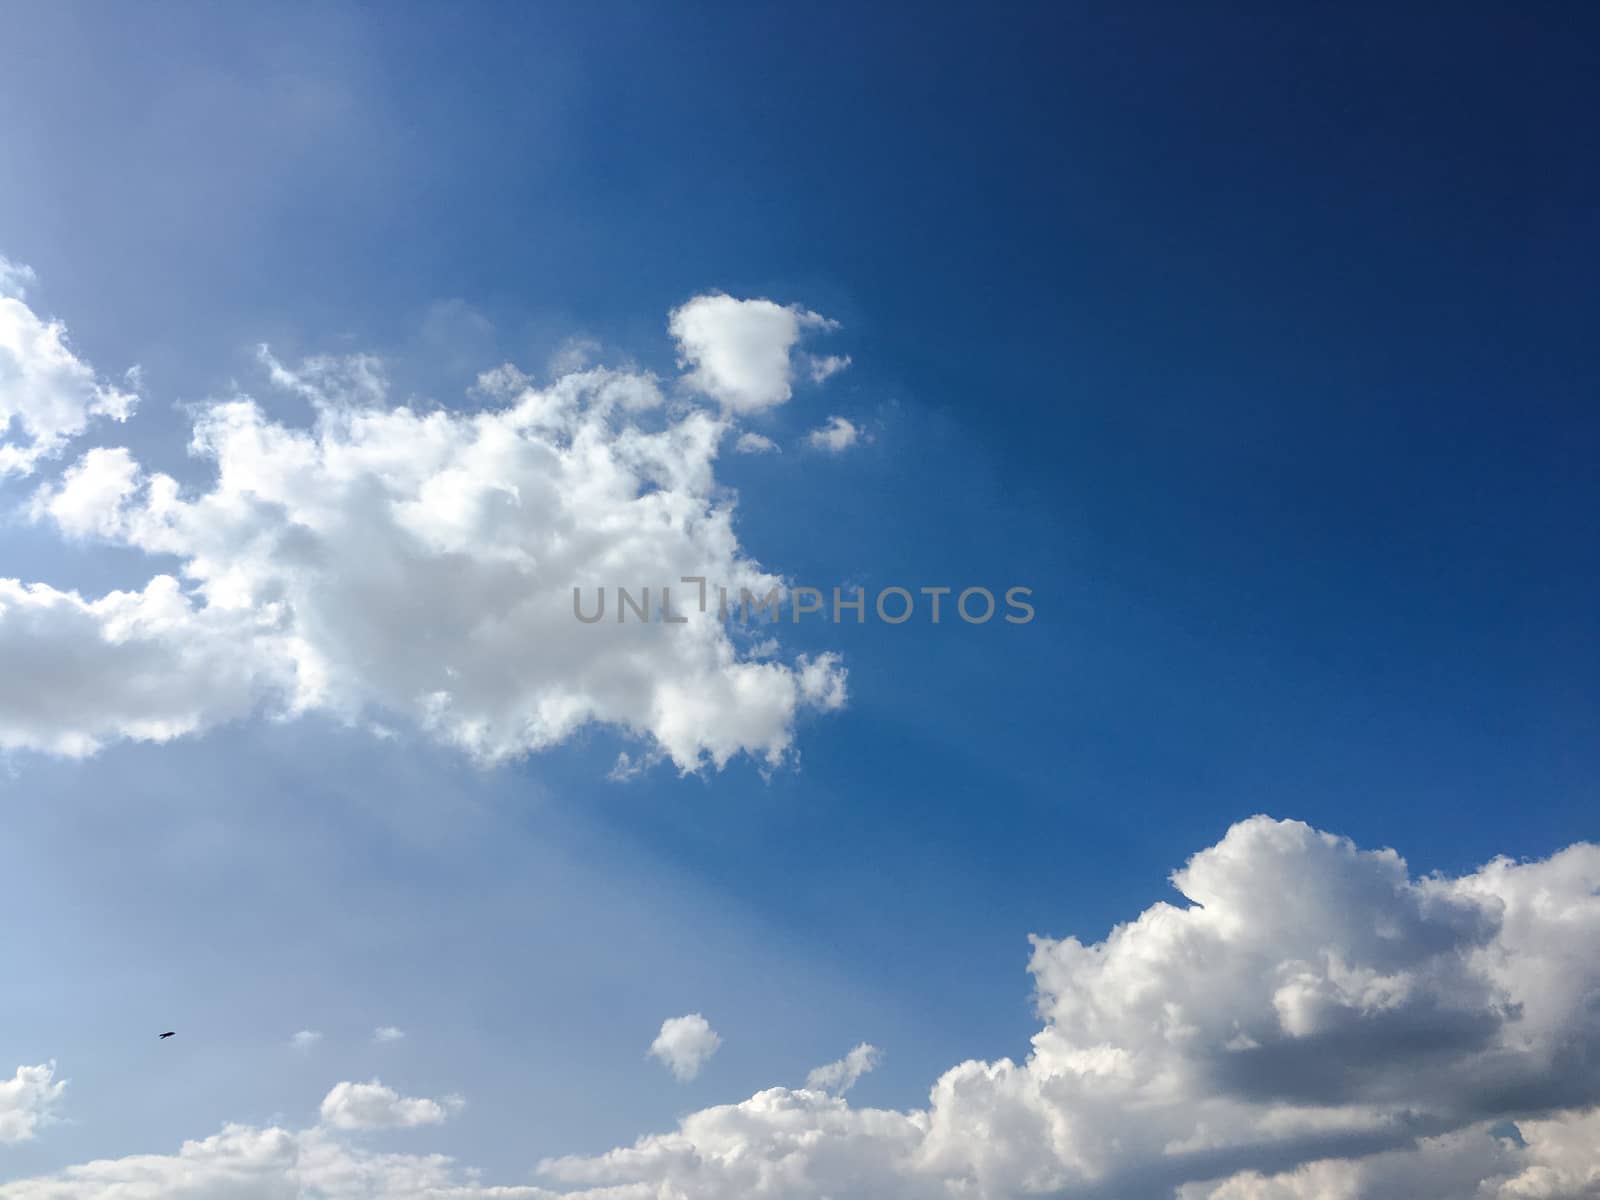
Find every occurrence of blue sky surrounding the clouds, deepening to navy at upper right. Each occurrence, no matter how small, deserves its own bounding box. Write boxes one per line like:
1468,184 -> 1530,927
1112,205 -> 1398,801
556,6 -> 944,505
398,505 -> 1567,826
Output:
0,5 -> 1600,1195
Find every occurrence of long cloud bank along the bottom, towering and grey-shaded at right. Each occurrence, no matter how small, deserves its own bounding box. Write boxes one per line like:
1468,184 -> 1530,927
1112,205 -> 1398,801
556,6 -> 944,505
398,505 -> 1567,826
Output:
12,818 -> 1600,1200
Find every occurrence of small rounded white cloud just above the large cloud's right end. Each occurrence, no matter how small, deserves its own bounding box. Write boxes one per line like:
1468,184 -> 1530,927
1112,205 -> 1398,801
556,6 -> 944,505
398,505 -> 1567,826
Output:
667,296 -> 842,413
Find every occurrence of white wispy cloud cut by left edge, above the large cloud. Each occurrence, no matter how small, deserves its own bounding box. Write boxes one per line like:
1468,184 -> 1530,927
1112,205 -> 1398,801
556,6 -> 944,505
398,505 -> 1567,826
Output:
0,258 -> 138,478
